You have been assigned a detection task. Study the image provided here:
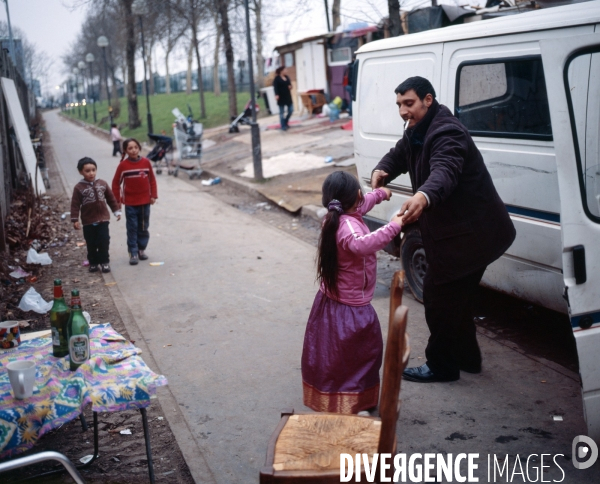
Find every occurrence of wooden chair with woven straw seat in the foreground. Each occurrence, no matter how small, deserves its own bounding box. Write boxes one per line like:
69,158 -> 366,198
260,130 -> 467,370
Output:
260,271 -> 410,484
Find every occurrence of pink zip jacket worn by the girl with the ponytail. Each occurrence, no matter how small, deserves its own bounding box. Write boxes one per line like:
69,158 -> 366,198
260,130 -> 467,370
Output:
321,188 -> 401,306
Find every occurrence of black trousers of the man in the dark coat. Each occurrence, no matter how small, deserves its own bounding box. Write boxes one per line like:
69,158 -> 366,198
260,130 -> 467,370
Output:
423,268 -> 485,379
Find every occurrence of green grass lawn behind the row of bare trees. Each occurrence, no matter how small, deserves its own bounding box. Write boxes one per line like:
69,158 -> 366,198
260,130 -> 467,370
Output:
65,92 -> 266,141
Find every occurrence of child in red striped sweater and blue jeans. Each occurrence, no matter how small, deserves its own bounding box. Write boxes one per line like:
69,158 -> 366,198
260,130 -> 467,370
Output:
112,138 -> 158,266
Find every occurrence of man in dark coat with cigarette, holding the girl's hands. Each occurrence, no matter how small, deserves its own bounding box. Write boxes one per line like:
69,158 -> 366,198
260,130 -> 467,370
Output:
371,77 -> 516,383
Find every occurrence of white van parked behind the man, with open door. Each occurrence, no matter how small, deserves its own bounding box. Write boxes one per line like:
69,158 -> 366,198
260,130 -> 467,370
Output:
353,1 -> 600,440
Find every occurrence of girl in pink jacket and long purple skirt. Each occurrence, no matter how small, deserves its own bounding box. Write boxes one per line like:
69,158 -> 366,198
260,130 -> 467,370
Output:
302,171 -> 402,413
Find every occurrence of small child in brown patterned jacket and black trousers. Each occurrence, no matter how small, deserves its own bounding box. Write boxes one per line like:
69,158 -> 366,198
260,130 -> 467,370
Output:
71,157 -> 121,272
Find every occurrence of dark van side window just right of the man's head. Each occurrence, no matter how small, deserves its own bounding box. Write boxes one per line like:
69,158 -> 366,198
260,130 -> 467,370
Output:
454,56 -> 552,141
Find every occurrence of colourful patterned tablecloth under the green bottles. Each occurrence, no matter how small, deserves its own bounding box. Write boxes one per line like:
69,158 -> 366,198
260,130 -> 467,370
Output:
0,324 -> 167,459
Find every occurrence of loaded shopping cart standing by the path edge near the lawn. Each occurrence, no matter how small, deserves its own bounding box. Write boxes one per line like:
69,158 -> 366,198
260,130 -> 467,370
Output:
171,106 -> 203,179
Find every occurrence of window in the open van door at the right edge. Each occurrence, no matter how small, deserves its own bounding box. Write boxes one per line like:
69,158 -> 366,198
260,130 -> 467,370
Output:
565,51 -> 600,223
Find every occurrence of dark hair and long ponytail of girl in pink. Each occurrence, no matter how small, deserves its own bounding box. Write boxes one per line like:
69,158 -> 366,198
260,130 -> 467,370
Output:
317,171 -> 360,300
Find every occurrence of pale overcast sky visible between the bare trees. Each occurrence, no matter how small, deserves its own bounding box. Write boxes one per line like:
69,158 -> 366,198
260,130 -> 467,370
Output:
0,0 -> 464,97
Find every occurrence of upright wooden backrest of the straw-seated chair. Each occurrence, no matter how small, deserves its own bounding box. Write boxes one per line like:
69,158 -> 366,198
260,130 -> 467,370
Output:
377,271 -> 410,454
